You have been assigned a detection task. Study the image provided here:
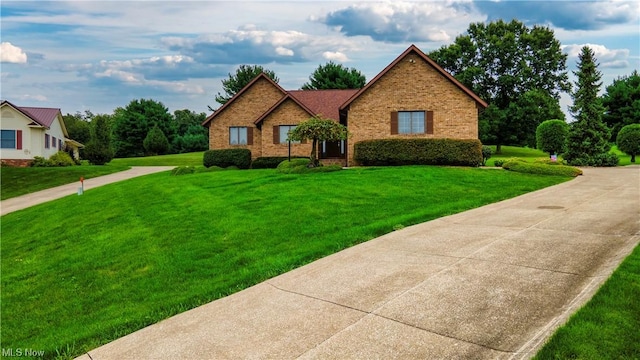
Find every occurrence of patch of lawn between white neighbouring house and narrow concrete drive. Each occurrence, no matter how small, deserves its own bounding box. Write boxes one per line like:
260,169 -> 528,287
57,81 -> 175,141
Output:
0,164 -> 129,200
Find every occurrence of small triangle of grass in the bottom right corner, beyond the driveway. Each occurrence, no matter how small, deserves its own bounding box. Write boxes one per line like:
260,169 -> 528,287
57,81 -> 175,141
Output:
534,246 -> 640,360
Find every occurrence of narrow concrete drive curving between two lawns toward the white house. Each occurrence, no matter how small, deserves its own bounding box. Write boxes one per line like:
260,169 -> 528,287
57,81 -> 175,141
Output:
0,166 -> 175,216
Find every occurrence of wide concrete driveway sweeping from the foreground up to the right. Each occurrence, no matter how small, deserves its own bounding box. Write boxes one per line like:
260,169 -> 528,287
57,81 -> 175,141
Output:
63,166 -> 640,360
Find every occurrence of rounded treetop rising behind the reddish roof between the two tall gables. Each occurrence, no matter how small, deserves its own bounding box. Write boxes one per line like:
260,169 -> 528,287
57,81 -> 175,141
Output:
302,61 -> 367,90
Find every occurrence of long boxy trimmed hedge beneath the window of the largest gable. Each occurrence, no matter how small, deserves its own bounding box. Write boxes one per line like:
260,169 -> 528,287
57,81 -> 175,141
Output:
354,139 -> 483,166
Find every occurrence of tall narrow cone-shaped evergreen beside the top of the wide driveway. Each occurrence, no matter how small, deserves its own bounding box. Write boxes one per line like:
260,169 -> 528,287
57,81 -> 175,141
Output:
564,46 -> 617,166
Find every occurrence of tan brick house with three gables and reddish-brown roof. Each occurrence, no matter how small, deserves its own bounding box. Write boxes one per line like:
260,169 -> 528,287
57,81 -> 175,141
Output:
203,45 -> 487,166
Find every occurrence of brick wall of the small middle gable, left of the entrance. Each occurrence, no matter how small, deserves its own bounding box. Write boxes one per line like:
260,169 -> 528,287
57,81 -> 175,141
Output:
261,99 -> 311,156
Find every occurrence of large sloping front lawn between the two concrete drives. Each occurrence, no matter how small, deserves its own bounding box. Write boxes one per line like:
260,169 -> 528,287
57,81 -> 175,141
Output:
0,166 -> 569,358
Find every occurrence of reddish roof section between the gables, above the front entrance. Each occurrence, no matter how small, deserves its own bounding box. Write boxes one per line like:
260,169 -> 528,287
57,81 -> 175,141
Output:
287,89 -> 359,121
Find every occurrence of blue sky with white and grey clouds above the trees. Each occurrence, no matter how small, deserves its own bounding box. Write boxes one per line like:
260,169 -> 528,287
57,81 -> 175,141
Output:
0,0 -> 640,119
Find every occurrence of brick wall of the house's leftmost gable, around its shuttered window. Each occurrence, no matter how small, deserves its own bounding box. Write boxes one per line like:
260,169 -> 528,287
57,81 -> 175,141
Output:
209,79 -> 284,159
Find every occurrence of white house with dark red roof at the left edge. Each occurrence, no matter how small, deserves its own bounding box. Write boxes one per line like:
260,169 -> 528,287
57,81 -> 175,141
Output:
0,100 -> 83,166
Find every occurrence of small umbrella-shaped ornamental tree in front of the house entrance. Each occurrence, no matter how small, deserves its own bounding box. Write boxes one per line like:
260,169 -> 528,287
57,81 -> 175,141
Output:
288,115 -> 349,167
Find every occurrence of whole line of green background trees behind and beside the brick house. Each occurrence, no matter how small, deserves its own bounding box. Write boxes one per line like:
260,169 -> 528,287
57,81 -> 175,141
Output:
65,20 -> 640,165
